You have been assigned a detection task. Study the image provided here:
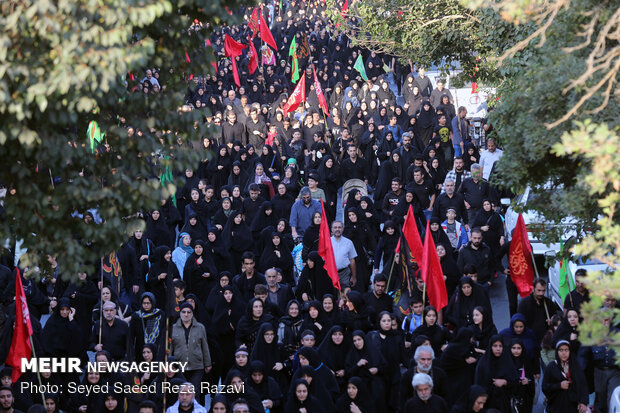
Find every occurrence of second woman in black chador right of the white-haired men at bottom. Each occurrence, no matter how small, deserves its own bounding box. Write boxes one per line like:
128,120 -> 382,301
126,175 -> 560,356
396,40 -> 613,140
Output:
475,335 -> 518,412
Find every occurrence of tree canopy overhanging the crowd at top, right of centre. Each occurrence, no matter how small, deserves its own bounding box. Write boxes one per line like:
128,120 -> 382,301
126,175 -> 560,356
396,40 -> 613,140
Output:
328,0 -> 527,81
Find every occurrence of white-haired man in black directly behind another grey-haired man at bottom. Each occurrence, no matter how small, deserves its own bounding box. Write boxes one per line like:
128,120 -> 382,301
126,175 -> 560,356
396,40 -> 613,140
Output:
400,346 -> 447,411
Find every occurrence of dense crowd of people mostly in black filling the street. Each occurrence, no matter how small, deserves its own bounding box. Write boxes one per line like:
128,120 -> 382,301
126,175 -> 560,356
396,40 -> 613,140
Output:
0,0 -> 620,413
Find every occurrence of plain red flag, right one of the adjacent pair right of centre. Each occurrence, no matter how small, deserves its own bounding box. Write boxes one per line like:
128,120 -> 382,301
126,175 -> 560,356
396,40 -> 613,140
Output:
422,221 -> 448,311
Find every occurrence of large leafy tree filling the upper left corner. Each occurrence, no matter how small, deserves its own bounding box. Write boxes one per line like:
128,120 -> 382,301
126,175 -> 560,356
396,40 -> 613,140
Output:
0,0 -> 247,275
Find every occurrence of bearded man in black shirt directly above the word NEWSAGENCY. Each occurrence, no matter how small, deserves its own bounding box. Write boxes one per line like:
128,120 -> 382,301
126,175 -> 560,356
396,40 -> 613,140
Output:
90,301 -> 129,361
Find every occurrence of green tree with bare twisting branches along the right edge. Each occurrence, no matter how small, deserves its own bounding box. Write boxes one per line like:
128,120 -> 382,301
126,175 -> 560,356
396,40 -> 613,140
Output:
470,0 -> 620,355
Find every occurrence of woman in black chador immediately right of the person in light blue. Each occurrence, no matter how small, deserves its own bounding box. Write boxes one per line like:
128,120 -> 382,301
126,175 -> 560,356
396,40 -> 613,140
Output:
183,240 -> 217,303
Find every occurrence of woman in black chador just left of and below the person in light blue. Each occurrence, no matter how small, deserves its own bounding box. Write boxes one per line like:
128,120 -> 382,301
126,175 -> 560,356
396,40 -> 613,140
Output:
146,245 -> 176,314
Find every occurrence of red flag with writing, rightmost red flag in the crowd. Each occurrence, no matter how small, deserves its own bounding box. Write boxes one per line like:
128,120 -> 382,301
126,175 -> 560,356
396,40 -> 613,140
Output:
508,214 -> 534,297
